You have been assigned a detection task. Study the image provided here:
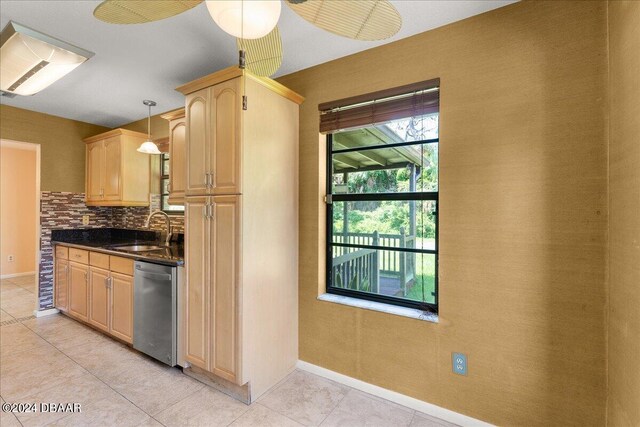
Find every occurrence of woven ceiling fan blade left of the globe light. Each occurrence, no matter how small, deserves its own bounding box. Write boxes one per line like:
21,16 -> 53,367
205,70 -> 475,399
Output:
93,0 -> 202,24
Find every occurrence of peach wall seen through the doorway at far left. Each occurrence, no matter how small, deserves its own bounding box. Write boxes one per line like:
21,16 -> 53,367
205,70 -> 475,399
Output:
0,146 -> 37,276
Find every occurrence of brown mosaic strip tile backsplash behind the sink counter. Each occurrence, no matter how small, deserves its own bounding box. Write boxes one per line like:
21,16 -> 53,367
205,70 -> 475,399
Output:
38,191 -> 184,310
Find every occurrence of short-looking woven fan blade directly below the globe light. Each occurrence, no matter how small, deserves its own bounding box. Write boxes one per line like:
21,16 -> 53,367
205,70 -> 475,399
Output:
236,26 -> 282,77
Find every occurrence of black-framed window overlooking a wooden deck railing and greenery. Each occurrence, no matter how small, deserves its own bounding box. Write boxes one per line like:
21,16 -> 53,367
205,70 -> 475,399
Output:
321,81 -> 439,313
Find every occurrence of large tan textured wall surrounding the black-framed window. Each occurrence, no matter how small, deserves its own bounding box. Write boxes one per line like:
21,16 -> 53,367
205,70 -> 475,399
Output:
279,1 -> 608,426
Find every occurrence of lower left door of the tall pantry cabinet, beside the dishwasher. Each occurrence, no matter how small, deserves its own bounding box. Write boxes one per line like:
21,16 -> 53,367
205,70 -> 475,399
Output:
185,197 -> 210,370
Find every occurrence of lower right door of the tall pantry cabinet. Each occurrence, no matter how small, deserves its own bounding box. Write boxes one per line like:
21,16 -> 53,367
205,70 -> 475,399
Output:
209,196 -> 240,382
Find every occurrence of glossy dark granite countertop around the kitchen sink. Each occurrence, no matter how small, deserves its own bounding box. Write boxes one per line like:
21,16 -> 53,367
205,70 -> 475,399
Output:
51,228 -> 184,266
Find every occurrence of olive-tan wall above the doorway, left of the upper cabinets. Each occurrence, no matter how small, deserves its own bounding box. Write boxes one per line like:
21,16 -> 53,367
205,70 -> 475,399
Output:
0,105 -> 109,193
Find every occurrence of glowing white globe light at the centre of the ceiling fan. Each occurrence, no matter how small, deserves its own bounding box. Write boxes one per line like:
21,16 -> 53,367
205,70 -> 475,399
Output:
206,0 -> 281,39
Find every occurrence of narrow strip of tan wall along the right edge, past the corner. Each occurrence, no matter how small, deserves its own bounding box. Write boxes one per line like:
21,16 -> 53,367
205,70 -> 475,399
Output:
607,1 -> 640,427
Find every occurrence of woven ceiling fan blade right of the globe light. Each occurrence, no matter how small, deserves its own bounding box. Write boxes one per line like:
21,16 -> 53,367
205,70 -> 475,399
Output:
285,0 -> 402,40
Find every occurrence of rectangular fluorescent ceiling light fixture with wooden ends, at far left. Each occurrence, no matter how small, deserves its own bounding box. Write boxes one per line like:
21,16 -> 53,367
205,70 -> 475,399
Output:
0,21 -> 94,96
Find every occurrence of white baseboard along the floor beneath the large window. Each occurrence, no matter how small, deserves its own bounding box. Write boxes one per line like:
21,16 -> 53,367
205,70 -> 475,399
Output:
296,360 -> 493,427
